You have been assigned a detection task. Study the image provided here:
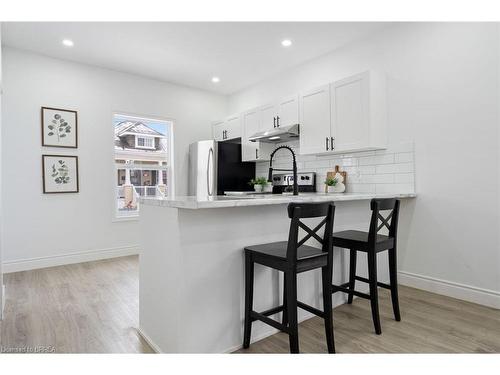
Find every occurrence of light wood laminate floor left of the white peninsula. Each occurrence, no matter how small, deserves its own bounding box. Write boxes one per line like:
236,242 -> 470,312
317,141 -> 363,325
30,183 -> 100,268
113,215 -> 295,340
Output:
0,256 -> 151,353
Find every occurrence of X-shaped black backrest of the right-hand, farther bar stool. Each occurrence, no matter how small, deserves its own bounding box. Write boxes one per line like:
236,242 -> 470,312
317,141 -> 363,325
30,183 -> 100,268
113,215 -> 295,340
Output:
368,198 -> 399,243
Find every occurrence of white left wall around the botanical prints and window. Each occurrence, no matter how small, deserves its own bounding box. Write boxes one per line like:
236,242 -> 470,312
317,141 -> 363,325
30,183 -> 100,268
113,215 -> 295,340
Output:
2,48 -> 227,271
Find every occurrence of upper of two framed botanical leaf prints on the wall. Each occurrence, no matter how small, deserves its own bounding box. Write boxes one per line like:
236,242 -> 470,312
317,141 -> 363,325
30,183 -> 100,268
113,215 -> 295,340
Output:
42,107 -> 78,148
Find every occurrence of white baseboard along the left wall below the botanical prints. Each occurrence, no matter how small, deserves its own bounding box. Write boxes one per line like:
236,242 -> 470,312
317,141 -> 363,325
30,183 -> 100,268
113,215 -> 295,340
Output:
2,245 -> 139,274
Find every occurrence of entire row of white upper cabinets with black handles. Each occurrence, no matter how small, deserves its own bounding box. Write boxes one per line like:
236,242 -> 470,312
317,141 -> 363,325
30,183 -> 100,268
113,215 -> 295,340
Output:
222,71 -> 387,161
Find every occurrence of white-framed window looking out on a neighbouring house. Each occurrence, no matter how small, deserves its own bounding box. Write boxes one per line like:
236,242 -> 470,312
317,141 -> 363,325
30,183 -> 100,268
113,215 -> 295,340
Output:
113,114 -> 173,218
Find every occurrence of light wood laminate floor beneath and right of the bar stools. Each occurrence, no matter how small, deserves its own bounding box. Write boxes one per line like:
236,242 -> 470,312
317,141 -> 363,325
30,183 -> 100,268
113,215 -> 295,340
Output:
239,286 -> 500,353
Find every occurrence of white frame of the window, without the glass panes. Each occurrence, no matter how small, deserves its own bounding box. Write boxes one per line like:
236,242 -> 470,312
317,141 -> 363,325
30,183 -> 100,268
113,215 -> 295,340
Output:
110,111 -> 176,222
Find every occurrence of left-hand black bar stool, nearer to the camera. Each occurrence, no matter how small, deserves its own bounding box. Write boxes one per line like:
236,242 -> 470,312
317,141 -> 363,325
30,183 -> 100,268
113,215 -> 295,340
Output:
243,202 -> 335,353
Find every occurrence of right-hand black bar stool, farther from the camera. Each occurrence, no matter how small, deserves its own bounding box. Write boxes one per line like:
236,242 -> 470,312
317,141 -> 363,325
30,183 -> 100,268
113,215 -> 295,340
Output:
332,199 -> 401,335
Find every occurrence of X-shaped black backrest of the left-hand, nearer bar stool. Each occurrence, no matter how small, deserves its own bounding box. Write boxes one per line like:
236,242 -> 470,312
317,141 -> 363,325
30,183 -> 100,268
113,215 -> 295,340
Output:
286,202 -> 335,264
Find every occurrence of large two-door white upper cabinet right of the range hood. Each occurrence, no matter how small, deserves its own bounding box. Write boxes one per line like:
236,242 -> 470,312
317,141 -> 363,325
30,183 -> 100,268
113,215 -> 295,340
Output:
300,71 -> 387,154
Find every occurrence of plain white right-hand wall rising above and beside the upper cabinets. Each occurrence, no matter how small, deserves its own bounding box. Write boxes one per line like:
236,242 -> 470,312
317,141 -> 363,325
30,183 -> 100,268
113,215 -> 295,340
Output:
229,23 -> 500,307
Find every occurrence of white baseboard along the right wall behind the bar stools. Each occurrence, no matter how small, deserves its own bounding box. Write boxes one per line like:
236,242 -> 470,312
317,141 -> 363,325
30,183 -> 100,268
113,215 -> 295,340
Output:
398,271 -> 500,309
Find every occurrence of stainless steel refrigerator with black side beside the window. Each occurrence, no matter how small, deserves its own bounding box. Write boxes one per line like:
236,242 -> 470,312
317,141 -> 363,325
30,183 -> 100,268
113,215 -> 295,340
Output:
189,140 -> 255,197
